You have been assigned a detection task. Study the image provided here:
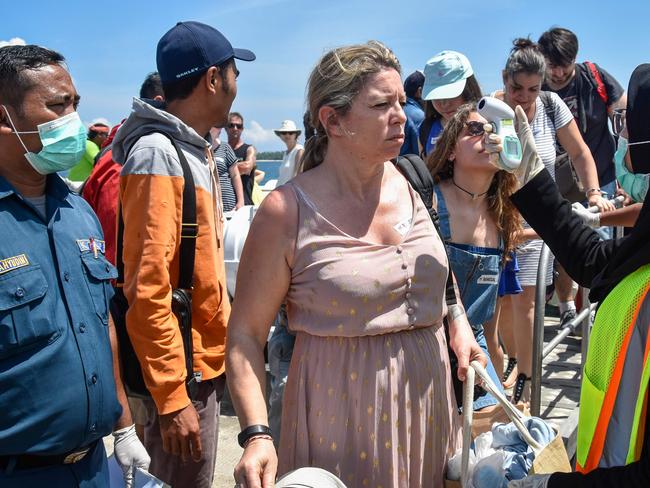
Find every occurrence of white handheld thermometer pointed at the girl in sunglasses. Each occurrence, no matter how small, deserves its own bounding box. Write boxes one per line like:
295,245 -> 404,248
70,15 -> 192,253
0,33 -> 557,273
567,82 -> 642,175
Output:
478,97 -> 522,173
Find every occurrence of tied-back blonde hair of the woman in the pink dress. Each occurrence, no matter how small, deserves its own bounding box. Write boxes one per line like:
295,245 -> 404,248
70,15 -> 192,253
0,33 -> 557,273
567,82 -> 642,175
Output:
302,41 -> 401,171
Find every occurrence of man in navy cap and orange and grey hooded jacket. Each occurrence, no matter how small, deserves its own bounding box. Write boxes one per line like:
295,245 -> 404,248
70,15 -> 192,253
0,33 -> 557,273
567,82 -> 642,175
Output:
112,22 -> 255,488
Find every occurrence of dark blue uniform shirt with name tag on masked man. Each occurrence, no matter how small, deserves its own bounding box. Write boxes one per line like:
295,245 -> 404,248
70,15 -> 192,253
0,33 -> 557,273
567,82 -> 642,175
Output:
0,175 -> 121,456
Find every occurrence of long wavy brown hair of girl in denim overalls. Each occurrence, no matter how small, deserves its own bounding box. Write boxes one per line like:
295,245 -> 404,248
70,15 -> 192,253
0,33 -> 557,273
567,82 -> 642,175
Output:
427,103 -> 522,261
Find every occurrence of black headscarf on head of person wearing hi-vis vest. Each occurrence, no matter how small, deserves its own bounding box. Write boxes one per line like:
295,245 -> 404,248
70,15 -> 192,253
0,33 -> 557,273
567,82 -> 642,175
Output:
626,64 -> 650,173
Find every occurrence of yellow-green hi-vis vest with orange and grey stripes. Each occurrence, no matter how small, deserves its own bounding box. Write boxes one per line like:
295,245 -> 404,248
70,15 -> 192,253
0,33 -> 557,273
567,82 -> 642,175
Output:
576,265 -> 650,473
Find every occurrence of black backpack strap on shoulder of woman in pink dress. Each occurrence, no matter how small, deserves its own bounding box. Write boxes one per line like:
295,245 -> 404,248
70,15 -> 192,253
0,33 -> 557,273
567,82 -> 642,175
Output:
393,154 -> 458,307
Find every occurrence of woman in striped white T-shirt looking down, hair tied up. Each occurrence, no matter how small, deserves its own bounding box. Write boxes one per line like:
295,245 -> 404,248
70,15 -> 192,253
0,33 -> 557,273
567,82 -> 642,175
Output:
494,39 -> 614,403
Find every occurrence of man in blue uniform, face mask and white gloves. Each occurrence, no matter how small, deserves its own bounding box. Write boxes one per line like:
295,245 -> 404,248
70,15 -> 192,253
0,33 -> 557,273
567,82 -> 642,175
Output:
0,46 -> 149,488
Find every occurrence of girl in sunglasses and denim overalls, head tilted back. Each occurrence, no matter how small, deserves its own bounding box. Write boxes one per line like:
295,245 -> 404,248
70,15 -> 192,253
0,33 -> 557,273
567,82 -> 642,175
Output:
427,103 -> 521,410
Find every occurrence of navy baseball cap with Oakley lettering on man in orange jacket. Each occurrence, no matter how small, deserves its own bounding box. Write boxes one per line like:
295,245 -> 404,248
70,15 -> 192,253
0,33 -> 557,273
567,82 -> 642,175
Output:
156,21 -> 255,85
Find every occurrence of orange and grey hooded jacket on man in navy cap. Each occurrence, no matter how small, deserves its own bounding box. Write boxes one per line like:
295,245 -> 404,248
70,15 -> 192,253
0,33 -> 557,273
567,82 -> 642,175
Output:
113,99 -> 230,414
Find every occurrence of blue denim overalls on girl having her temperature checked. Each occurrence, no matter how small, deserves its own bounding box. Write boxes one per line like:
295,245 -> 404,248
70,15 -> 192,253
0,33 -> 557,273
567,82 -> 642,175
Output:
435,186 -> 503,410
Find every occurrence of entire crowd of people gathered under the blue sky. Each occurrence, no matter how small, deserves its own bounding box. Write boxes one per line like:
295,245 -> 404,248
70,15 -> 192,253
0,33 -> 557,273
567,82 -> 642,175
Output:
0,17 -> 650,488
